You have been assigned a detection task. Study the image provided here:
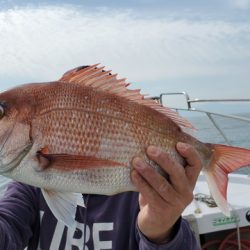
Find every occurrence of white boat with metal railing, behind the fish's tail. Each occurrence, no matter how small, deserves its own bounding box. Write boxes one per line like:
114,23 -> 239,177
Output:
153,92 -> 250,250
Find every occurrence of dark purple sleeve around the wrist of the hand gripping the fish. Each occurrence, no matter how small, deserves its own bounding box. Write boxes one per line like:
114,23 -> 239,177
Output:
137,218 -> 199,250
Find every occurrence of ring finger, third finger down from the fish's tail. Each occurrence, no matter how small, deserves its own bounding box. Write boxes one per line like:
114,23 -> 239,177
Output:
132,157 -> 177,202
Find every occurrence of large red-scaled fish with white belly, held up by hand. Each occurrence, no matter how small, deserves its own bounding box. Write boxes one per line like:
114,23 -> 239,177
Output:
0,64 -> 250,227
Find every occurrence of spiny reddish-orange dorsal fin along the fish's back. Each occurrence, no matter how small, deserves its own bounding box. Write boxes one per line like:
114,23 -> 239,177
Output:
59,64 -> 194,129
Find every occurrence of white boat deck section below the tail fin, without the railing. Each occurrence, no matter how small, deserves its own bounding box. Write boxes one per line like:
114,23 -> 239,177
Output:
182,174 -> 250,250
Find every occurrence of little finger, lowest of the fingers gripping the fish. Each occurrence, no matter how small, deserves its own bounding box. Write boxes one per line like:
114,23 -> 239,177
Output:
131,170 -> 164,207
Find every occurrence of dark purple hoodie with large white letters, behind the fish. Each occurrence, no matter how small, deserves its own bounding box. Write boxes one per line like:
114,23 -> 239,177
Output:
0,182 -> 199,250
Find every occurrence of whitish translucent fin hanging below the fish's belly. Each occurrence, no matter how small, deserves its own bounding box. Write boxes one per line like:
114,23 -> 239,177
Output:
42,189 -> 85,228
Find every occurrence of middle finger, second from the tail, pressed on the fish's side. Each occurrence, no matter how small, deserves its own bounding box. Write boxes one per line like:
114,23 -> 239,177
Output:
147,146 -> 188,193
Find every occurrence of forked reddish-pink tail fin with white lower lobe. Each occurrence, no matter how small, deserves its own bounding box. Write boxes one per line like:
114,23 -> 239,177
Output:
203,144 -> 250,216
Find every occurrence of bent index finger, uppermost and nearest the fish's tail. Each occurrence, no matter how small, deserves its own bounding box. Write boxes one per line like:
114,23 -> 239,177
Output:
176,142 -> 202,186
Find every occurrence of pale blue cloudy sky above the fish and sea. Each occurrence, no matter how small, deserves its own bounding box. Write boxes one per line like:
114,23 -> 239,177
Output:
0,0 -> 250,111
